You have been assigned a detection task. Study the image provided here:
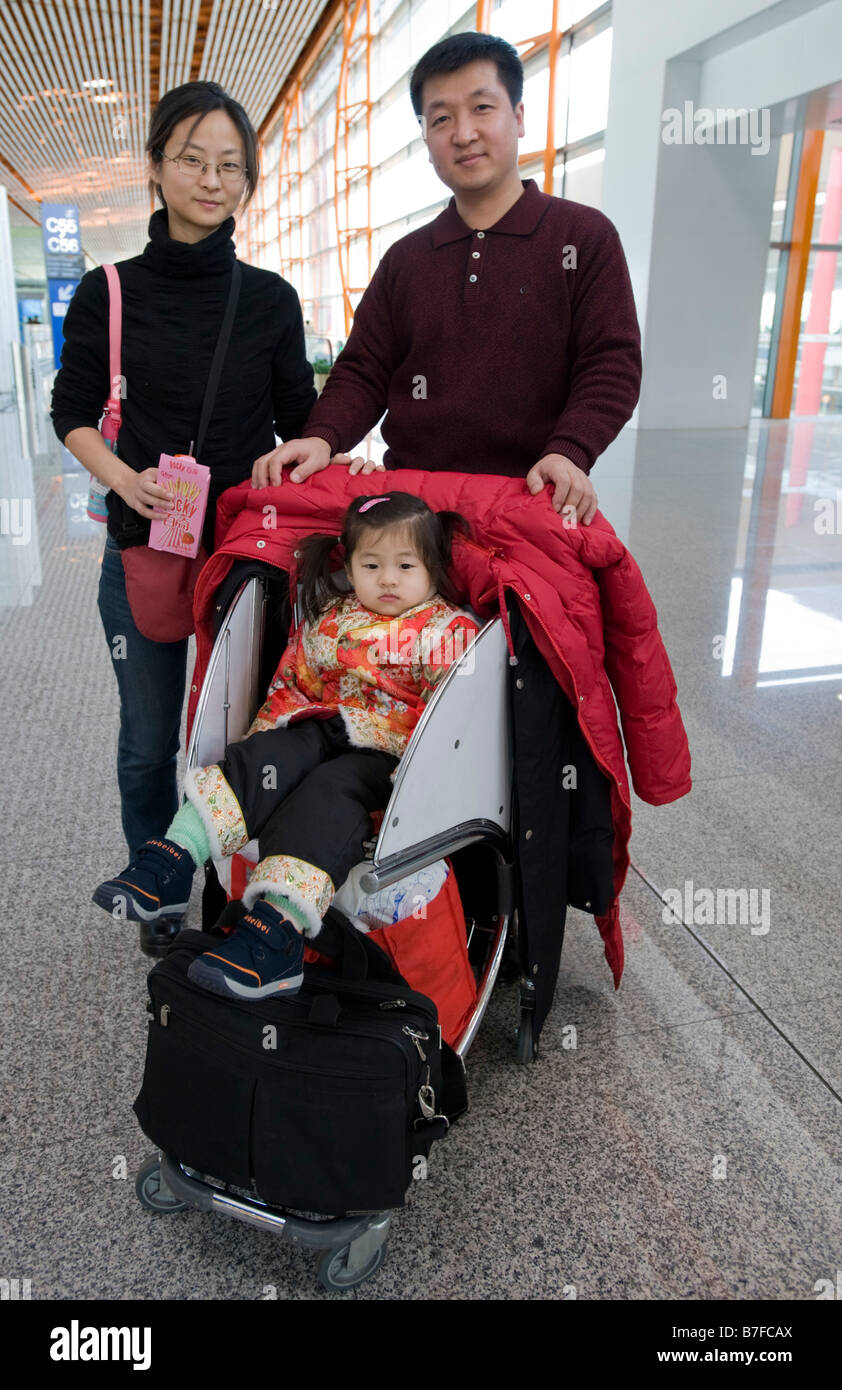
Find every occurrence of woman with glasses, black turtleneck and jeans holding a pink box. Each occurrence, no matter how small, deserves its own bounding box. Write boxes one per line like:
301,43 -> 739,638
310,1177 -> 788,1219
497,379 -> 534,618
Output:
53,82 -> 315,949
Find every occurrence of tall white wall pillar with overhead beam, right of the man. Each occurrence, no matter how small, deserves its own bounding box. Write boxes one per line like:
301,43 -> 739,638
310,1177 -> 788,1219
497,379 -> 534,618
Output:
602,0 -> 842,428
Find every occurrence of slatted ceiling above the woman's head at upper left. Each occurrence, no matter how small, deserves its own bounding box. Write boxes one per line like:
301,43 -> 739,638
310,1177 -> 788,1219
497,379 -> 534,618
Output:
0,0 -> 325,264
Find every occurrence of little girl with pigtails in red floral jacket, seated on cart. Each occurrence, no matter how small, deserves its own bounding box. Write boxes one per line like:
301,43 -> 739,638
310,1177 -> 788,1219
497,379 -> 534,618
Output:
93,492 -> 477,998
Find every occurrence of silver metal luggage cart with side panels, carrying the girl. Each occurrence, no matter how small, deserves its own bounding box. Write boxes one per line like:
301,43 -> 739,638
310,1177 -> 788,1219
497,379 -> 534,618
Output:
135,562 -> 536,1290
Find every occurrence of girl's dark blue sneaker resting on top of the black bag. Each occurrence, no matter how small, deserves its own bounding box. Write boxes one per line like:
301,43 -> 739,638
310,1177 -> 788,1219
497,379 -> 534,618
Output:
188,898 -> 304,999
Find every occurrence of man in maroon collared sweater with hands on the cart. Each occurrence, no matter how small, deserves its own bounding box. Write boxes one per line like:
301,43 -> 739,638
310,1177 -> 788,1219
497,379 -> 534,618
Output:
253,33 -> 641,524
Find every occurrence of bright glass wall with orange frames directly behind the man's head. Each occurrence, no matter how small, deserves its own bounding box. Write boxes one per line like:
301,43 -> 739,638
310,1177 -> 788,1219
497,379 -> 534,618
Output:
257,0 -> 611,360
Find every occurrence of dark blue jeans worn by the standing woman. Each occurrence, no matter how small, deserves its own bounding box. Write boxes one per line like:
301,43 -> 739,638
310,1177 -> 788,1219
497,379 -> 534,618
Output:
99,537 -> 188,858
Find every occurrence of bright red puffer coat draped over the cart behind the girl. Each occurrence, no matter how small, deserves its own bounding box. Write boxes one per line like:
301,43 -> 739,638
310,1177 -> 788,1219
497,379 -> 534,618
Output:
188,466 -> 691,984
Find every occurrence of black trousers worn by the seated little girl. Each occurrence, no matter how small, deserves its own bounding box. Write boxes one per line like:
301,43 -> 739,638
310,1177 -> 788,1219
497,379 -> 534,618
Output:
220,714 -> 400,888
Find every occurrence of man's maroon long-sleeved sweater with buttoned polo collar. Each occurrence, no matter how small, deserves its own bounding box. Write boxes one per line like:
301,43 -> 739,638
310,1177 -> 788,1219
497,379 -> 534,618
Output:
303,179 -> 641,477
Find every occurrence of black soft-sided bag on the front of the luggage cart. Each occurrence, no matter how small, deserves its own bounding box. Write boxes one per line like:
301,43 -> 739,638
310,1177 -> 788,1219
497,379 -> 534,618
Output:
135,908 -> 467,1216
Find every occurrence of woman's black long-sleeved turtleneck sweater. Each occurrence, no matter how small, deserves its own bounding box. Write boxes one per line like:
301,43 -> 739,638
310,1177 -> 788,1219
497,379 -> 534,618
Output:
53,210 -> 315,549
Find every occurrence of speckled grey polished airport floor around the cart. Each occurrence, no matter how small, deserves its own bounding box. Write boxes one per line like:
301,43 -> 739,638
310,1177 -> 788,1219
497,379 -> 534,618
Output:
0,420 -> 842,1301
